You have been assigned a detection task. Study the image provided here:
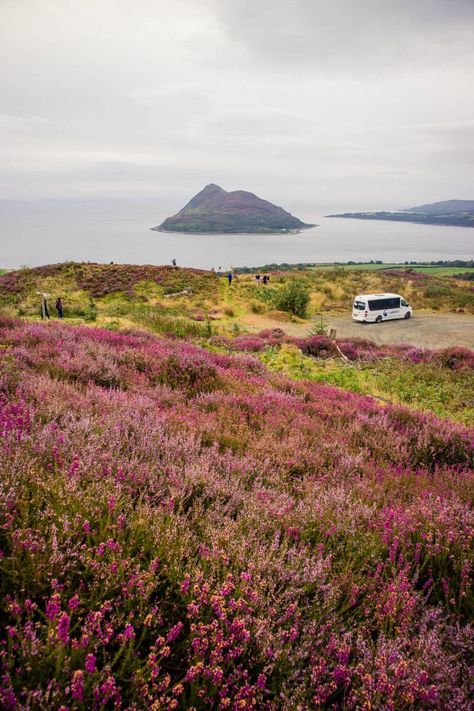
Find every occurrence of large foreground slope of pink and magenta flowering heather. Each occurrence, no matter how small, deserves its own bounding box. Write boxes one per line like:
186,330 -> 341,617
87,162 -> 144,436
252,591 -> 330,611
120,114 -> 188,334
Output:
0,320 -> 474,710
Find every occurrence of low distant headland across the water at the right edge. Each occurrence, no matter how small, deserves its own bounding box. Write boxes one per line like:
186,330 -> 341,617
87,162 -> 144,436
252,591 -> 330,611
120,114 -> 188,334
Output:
326,200 -> 474,227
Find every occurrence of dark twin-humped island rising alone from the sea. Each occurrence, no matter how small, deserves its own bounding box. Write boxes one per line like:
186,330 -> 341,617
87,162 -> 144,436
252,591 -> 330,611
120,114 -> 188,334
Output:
151,183 -> 315,234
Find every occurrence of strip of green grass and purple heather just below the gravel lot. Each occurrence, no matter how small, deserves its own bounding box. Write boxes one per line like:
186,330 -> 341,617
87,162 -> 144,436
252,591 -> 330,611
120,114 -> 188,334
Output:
217,328 -> 474,425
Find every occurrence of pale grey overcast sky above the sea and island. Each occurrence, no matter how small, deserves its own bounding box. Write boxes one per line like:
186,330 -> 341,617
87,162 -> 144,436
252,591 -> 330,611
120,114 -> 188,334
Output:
0,0 -> 474,209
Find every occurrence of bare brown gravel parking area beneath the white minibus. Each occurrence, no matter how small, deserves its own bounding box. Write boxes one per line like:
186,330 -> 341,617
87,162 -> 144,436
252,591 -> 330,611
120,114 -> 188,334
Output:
243,312 -> 474,349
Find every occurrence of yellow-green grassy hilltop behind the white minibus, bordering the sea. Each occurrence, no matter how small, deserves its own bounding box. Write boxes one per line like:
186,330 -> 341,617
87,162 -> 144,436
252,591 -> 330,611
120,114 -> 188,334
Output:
0,263 -> 474,330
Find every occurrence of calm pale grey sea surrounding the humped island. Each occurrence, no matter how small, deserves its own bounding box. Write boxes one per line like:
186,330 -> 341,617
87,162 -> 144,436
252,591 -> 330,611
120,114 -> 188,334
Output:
0,201 -> 474,269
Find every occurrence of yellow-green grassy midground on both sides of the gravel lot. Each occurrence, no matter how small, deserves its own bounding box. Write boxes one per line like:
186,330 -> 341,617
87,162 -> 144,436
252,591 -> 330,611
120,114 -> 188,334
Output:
0,264 -> 474,424
